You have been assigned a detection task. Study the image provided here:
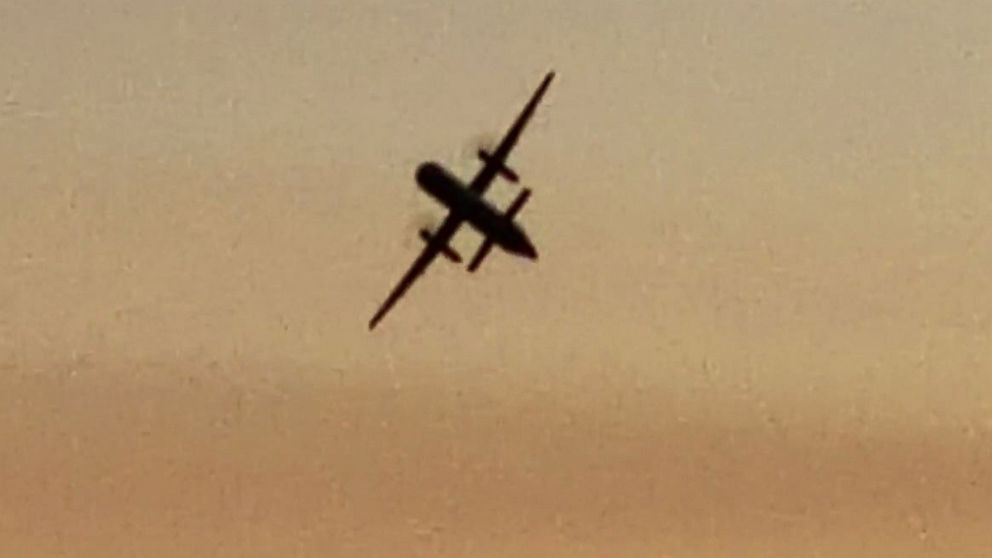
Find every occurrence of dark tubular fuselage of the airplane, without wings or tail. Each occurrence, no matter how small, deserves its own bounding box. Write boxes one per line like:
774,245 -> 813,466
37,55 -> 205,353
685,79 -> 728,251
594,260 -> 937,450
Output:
416,162 -> 537,259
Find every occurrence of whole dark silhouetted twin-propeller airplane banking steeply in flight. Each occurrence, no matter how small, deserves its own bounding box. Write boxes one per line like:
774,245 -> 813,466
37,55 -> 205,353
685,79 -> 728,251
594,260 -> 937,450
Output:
369,71 -> 555,331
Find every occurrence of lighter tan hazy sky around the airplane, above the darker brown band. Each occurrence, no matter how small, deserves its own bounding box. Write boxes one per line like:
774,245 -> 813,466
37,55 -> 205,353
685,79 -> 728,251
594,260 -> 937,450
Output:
0,0 -> 992,556
